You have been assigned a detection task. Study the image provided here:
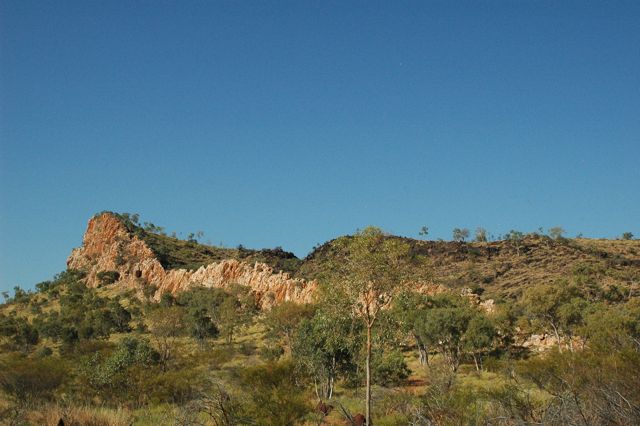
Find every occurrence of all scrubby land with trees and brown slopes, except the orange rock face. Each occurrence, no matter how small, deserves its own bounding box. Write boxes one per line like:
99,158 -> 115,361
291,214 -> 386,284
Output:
0,216 -> 640,426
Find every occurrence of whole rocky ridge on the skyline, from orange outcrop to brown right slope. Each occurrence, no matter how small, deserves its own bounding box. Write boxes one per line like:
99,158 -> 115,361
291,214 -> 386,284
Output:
67,213 -> 640,308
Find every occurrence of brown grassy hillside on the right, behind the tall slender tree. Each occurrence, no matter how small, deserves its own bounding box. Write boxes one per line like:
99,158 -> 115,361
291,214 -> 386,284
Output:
296,235 -> 640,298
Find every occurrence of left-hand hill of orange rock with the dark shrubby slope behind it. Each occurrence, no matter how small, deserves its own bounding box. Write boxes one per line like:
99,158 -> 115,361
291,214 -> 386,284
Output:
67,213 -> 316,308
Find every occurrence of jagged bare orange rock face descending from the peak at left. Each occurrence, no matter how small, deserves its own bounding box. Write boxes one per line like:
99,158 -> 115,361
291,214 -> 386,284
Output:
67,213 -> 317,309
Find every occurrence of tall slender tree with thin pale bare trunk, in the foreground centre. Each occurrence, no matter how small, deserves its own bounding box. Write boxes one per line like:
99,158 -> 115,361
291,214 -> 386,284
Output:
331,227 -> 410,424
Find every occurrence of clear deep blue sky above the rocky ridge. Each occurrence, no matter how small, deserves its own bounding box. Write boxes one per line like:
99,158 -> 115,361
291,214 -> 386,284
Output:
0,0 -> 640,289
